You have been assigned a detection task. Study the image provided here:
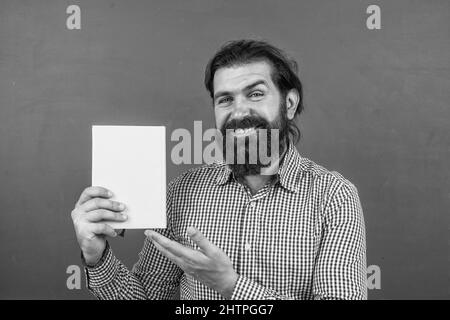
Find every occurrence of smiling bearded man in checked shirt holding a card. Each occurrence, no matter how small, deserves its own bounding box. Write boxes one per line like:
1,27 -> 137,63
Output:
72,40 -> 367,299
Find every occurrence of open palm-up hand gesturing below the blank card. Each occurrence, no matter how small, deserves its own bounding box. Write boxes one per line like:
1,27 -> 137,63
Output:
145,227 -> 238,299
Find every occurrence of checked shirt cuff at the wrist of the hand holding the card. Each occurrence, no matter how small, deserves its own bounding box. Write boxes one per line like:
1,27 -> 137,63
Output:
81,243 -> 119,289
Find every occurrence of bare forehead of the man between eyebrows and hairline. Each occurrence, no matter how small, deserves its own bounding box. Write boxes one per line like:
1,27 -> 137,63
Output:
214,61 -> 272,92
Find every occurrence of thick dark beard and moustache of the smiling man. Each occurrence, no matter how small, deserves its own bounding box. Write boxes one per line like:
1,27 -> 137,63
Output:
220,103 -> 289,178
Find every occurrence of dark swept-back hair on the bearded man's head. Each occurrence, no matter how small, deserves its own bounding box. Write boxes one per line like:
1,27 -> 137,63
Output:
205,40 -> 304,143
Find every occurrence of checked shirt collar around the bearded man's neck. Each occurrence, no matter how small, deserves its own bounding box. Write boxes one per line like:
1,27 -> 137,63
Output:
216,142 -> 302,193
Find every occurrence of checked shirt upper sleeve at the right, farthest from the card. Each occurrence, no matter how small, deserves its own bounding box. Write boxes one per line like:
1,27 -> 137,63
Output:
313,182 -> 367,300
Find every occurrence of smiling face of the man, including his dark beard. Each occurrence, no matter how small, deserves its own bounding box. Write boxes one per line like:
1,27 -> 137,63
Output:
214,61 -> 288,176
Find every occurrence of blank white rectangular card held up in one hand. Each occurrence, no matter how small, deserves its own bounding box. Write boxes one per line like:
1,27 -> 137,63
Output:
92,126 -> 166,229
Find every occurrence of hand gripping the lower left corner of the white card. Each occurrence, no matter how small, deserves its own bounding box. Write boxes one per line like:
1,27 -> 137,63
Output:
72,187 -> 127,265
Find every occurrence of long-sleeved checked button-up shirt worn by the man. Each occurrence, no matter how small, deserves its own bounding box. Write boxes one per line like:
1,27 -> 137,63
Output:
85,144 -> 367,299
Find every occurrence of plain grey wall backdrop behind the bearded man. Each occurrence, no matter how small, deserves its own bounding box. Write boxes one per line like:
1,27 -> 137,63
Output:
0,0 -> 450,299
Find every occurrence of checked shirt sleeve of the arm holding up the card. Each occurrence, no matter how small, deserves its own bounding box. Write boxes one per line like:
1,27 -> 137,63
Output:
85,179 -> 183,300
